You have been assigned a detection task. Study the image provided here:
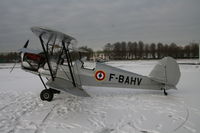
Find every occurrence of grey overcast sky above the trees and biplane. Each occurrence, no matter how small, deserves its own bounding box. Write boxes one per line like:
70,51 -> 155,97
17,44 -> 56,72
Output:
0,0 -> 200,52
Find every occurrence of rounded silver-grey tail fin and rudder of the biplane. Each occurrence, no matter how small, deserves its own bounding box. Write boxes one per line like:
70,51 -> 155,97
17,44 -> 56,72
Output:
149,57 -> 181,87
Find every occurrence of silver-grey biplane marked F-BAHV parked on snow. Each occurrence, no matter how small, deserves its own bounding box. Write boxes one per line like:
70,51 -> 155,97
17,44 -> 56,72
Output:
19,27 -> 180,101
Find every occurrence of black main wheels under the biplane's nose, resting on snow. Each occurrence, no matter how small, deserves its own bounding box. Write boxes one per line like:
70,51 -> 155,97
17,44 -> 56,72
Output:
40,88 -> 60,102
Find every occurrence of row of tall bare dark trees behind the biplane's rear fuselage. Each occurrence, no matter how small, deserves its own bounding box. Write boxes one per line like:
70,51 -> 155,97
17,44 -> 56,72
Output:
103,41 -> 199,60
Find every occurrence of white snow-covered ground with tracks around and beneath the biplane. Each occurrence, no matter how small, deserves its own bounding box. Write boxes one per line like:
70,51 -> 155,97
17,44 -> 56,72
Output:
0,60 -> 200,133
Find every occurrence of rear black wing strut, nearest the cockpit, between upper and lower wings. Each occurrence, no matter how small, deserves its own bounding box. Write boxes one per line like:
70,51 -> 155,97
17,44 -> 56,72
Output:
62,41 -> 76,87
